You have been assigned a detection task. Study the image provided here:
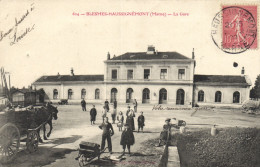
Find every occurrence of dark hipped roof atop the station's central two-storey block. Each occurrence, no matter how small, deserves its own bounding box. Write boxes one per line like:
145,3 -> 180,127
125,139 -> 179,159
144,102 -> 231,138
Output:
110,52 -> 190,60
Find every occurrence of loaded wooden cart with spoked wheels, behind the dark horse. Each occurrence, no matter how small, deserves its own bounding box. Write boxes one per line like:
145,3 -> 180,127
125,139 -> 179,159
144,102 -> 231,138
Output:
0,109 -> 42,163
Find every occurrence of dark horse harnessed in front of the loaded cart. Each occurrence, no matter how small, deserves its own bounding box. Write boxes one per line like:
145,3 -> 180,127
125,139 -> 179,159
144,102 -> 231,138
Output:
35,104 -> 59,143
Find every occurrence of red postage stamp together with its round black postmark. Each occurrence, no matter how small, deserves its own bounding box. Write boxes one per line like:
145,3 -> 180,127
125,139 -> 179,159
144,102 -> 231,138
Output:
211,6 -> 258,54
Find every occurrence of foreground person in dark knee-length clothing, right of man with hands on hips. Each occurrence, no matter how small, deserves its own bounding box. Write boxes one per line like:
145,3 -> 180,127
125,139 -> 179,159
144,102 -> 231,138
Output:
120,124 -> 135,155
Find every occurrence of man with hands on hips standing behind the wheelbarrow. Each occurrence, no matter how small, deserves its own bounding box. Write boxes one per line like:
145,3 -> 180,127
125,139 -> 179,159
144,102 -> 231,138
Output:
99,117 -> 114,154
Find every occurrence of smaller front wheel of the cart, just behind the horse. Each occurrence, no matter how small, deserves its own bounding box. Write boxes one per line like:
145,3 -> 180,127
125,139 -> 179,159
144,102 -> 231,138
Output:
26,131 -> 39,153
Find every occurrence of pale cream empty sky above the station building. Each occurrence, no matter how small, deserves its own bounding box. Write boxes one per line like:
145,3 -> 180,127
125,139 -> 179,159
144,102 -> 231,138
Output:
0,0 -> 260,88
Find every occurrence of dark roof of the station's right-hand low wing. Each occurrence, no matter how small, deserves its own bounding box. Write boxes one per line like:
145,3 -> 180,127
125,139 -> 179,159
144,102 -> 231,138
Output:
194,75 -> 249,85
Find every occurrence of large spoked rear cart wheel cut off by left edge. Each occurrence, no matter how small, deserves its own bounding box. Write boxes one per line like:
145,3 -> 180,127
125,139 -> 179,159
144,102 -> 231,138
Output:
0,123 -> 20,163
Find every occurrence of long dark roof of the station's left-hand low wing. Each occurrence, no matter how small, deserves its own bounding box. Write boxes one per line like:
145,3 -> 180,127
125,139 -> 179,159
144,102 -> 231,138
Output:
35,75 -> 104,82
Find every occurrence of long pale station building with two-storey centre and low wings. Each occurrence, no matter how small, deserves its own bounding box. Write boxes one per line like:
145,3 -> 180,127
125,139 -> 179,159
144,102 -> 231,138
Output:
33,46 -> 251,106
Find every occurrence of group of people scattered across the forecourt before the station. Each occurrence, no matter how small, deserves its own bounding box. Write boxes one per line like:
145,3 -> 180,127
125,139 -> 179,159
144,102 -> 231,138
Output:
81,99 -> 172,155
